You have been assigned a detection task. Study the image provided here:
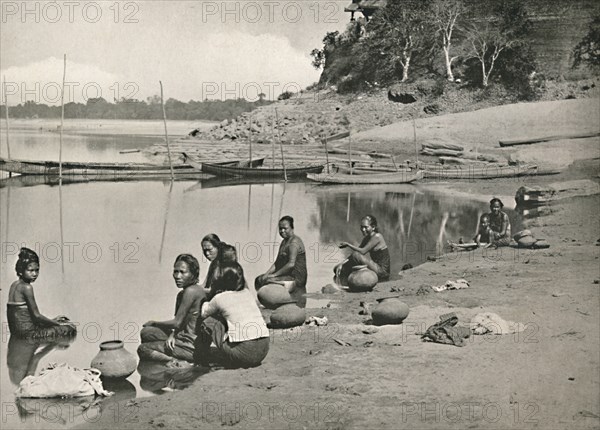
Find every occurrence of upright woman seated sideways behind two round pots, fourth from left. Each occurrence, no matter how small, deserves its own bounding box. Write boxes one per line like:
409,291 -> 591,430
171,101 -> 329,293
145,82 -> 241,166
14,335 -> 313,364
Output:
254,215 -> 308,307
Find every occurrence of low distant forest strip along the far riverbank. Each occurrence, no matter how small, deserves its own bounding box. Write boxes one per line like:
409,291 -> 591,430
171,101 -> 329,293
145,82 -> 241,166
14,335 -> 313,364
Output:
0,96 -> 272,121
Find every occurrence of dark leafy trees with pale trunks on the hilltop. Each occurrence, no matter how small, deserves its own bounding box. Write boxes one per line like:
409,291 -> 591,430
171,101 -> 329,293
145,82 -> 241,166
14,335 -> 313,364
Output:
311,0 -> 600,94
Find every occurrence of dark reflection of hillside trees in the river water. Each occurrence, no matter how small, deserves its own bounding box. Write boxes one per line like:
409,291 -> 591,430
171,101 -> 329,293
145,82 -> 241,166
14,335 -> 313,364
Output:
311,191 -> 487,273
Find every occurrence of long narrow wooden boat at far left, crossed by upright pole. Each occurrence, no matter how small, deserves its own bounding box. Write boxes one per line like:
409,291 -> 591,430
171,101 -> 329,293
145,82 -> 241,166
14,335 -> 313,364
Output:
0,158 -> 201,178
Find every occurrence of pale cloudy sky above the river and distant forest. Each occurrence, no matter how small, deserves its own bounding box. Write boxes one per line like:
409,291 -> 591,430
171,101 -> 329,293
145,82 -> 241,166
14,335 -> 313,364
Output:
0,0 -> 351,105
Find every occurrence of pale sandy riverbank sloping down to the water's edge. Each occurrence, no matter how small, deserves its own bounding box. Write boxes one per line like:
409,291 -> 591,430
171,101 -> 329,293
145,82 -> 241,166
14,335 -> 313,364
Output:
78,99 -> 600,429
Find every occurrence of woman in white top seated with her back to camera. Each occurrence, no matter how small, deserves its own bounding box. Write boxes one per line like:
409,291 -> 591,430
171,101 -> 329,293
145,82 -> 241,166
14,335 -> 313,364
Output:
194,263 -> 269,368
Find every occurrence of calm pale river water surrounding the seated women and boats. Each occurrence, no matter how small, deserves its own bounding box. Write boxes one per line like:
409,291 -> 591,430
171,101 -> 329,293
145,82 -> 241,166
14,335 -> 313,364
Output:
0,119 -> 516,428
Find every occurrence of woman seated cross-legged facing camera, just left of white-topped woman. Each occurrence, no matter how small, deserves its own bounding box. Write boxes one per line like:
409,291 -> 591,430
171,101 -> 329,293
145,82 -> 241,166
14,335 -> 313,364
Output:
138,254 -> 206,366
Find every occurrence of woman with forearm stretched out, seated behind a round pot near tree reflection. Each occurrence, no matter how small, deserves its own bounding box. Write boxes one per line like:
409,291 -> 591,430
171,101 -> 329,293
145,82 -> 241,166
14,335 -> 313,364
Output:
333,215 -> 390,285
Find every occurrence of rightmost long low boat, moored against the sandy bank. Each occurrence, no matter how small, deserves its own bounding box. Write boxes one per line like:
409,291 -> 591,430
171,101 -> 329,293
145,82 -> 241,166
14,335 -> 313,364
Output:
423,165 -> 560,180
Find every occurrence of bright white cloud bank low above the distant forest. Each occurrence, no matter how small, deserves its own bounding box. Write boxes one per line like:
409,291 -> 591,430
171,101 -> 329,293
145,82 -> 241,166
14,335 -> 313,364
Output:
1,32 -> 319,105
